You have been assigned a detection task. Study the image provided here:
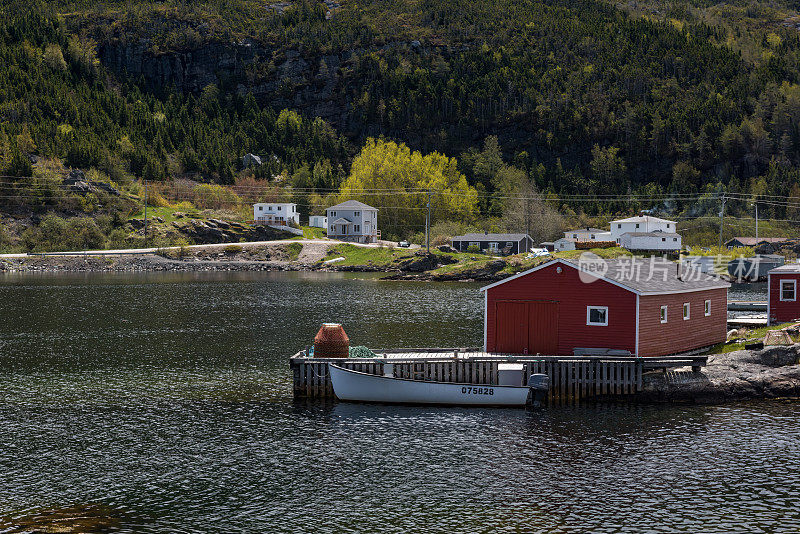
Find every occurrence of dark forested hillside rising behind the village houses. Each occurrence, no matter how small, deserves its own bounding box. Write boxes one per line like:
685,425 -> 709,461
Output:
0,0 -> 800,249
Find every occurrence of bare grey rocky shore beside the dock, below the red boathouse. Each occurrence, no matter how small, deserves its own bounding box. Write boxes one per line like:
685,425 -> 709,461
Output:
636,344 -> 800,404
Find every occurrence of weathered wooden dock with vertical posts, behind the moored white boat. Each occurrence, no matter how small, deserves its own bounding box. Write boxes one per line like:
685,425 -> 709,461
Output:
289,349 -> 707,403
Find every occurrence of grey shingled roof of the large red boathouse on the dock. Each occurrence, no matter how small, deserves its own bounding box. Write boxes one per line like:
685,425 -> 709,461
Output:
481,256 -> 728,295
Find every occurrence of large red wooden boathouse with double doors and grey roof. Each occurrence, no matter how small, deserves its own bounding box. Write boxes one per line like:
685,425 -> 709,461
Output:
482,257 -> 730,356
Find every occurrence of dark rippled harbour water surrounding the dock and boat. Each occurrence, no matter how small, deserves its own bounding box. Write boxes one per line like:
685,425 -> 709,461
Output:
0,273 -> 800,533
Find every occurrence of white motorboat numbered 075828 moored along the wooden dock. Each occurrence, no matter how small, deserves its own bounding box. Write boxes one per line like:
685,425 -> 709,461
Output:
328,364 -> 544,406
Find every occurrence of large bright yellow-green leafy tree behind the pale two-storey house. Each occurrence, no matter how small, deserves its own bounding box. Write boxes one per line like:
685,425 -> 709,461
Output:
339,139 -> 477,238
